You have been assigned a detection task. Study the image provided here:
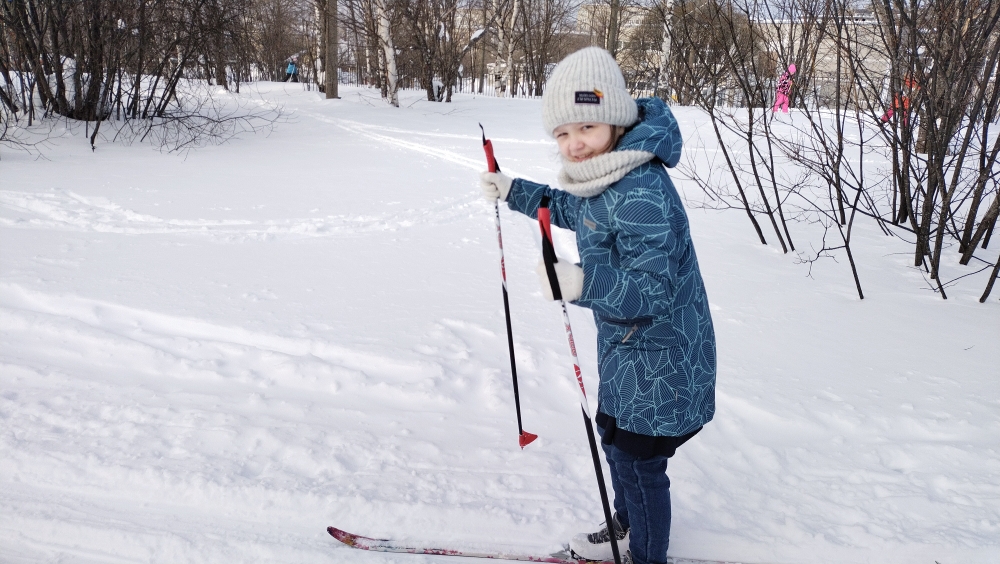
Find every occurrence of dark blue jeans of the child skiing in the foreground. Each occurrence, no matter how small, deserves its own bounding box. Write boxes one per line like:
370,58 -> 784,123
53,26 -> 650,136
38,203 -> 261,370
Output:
598,427 -> 670,564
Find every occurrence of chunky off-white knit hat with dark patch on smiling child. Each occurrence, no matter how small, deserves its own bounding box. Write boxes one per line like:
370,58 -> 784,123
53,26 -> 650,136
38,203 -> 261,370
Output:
542,47 -> 639,135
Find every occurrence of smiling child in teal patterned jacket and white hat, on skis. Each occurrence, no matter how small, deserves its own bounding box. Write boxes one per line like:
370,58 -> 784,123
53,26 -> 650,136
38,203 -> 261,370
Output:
480,47 -> 716,564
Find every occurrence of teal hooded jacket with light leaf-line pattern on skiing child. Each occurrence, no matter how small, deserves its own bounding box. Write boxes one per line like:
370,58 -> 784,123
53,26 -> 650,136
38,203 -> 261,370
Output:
507,98 -> 715,436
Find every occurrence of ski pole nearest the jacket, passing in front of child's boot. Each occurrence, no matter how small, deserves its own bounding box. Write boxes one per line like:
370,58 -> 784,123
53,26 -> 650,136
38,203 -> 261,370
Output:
538,196 -> 621,564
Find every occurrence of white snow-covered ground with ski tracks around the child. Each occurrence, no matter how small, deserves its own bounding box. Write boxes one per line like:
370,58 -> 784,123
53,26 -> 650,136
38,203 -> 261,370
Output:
0,84 -> 1000,564
